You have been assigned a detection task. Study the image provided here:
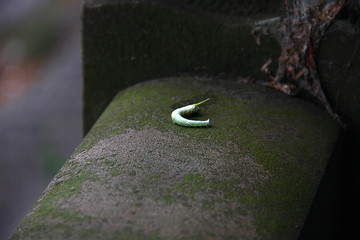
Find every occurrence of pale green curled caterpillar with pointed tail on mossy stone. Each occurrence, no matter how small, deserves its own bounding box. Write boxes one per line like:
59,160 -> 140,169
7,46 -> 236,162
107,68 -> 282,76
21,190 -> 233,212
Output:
171,98 -> 210,127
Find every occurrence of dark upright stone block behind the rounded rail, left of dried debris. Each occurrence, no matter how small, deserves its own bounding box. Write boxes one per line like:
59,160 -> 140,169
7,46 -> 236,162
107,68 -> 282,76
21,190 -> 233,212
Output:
82,0 -> 283,133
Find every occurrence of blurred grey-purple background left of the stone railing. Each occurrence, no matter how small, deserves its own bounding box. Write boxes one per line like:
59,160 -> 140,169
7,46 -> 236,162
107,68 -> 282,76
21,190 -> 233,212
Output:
0,0 -> 82,240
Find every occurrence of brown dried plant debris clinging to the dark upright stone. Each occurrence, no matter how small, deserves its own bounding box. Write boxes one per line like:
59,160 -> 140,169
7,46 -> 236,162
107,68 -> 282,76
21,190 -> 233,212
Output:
262,0 -> 345,127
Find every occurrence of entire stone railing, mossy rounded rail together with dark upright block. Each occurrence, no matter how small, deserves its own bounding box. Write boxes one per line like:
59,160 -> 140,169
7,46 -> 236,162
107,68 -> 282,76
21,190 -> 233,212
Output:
12,0 -> 358,239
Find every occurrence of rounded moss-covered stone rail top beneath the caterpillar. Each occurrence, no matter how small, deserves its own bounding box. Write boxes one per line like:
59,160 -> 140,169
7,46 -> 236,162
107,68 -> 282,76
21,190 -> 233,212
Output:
12,78 -> 339,239
